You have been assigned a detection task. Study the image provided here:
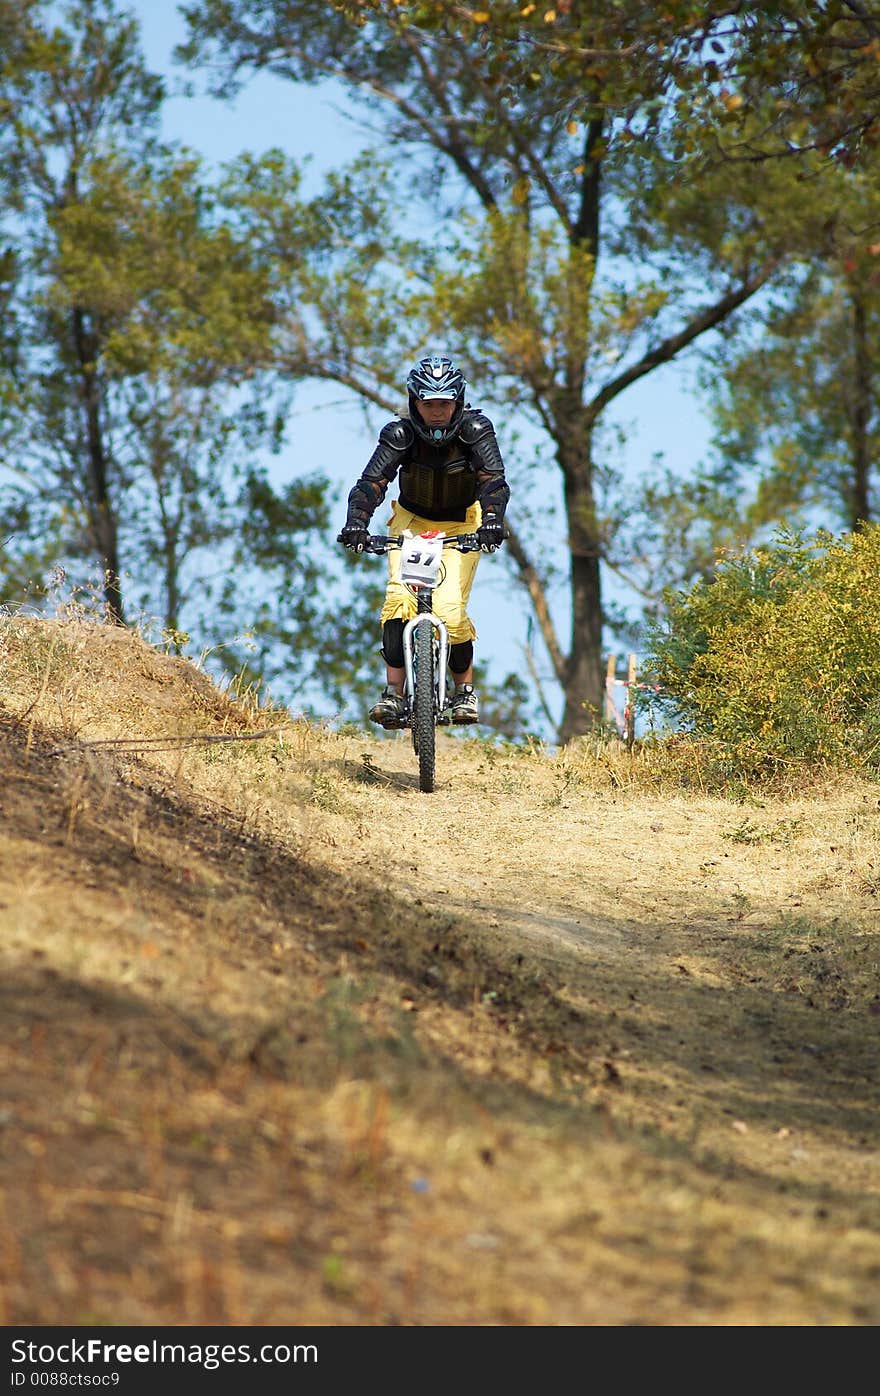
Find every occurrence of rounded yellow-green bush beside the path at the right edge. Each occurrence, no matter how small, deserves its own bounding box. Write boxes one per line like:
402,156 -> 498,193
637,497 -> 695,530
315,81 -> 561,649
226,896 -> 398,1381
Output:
647,525 -> 880,775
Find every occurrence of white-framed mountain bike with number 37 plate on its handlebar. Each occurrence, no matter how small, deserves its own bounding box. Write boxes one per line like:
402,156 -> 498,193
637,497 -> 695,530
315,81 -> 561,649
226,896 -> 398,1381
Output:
354,532 -> 481,794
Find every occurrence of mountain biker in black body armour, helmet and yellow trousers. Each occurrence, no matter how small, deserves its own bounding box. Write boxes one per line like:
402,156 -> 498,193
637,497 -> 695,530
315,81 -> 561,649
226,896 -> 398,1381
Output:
338,355 -> 510,727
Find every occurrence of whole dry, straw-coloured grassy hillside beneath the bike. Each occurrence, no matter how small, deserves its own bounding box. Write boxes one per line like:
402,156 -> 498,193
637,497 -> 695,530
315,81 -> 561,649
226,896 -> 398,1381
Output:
0,617 -> 880,1325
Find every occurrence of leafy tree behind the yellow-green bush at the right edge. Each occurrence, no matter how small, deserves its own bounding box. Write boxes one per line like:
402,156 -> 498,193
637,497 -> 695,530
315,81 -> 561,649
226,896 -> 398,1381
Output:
614,140 -> 880,617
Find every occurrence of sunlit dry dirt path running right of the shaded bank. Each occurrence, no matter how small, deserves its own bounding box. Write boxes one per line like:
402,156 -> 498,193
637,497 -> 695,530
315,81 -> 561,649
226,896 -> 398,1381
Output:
308,744 -> 880,1322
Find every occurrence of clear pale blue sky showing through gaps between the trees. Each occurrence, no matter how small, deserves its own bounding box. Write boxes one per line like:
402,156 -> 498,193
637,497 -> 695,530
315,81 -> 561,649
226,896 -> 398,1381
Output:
129,0 -> 708,720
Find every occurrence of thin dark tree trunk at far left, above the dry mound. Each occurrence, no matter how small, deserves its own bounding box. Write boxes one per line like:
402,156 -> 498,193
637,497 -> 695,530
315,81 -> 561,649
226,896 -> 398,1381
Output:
71,314 -> 126,625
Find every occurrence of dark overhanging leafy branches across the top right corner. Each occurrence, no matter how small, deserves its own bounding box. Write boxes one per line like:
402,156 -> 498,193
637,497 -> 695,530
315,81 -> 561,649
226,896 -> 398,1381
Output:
435,0 -> 880,166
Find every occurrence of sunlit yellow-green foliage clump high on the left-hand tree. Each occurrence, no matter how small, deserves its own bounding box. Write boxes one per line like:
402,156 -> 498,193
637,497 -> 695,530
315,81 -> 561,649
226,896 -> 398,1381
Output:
47,149 -> 274,376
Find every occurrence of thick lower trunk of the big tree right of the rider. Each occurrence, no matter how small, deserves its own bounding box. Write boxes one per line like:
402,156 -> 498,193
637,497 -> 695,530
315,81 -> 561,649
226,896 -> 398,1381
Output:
559,461 -> 605,744
